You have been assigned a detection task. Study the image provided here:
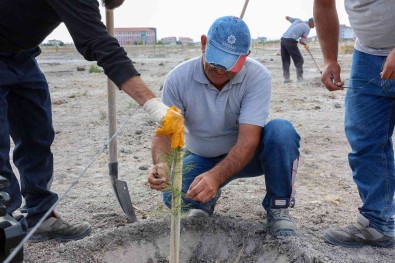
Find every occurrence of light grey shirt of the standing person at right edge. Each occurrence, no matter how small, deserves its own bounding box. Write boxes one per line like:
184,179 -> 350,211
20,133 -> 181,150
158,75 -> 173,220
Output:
345,0 -> 395,56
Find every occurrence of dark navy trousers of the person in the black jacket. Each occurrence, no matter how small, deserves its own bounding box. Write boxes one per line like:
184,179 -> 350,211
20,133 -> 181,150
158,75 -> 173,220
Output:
0,48 -> 58,227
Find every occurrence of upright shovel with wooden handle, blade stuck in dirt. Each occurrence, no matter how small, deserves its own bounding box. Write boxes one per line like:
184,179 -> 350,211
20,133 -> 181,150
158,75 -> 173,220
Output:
106,9 -> 137,223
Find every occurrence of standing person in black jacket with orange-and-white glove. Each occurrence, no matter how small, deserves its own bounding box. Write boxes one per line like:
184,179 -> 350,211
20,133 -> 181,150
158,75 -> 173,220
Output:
0,0 -> 183,241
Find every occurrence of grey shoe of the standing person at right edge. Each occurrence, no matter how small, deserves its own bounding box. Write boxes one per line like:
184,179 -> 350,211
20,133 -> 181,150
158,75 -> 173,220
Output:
324,214 -> 395,248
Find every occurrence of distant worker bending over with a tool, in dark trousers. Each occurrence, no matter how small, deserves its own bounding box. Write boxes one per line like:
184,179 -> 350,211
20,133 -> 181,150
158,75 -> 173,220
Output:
281,16 -> 314,83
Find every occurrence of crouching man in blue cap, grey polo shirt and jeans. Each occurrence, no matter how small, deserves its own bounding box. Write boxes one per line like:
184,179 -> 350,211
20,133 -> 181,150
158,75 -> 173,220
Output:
148,16 -> 300,236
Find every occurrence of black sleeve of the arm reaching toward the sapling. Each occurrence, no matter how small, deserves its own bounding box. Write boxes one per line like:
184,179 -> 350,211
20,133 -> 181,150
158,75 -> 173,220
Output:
48,0 -> 139,88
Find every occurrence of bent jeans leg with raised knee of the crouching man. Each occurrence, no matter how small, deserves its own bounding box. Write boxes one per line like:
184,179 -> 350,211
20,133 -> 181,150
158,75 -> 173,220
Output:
232,119 -> 300,210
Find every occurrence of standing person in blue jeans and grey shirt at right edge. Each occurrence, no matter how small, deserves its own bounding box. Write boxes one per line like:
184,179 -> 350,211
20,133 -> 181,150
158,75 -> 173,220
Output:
314,0 -> 395,247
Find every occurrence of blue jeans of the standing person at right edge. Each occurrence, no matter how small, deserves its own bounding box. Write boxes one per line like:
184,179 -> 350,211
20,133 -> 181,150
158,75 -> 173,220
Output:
345,50 -> 395,236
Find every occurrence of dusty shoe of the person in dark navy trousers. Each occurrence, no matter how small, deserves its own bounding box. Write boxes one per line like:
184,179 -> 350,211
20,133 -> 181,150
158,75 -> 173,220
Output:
30,214 -> 92,242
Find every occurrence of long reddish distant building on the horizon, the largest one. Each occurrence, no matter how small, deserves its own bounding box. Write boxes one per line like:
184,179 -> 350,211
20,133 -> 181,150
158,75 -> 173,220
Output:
114,27 -> 157,45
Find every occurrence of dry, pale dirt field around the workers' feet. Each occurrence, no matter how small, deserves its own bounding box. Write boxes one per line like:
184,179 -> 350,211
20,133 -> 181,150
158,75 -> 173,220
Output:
11,43 -> 395,263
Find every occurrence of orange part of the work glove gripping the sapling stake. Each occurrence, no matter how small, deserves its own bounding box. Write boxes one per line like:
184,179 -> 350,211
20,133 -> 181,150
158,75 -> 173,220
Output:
156,105 -> 184,149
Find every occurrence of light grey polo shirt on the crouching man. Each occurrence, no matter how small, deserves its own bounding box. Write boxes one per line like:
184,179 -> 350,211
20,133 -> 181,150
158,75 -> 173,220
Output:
162,56 -> 272,157
